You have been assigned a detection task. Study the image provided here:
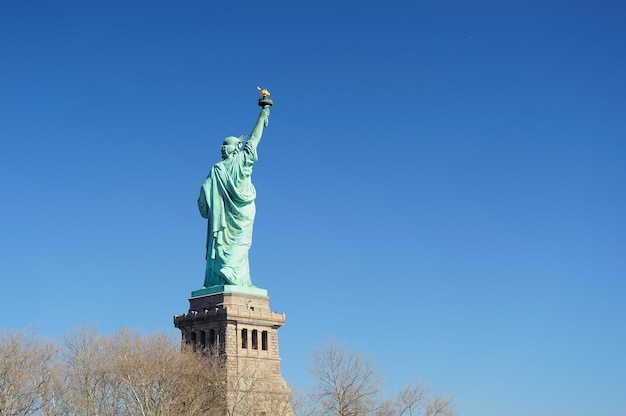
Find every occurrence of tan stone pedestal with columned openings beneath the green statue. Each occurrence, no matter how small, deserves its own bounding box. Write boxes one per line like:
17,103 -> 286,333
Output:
174,286 -> 293,416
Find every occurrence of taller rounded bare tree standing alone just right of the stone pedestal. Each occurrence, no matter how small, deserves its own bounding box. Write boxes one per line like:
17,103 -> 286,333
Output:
311,341 -> 383,416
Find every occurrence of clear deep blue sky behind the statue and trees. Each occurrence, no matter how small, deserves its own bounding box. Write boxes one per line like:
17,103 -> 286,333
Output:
0,0 -> 626,416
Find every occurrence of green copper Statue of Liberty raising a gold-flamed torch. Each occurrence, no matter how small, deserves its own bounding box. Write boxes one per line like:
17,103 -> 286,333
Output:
198,87 -> 273,288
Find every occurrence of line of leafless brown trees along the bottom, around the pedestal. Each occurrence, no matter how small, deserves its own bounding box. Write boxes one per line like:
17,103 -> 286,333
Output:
0,325 -> 456,416
